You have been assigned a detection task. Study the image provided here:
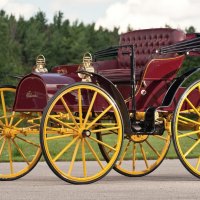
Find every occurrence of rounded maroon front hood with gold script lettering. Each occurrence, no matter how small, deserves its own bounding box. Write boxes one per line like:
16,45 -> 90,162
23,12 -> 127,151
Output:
14,73 -> 75,112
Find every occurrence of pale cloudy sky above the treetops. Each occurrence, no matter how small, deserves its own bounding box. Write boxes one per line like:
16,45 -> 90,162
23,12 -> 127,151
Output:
0,0 -> 200,32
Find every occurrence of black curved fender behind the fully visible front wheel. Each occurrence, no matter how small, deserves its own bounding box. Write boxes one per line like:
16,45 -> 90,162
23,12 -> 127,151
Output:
79,71 -> 132,134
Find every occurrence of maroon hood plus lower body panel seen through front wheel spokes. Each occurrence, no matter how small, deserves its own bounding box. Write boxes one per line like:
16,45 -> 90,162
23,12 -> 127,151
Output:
14,72 -> 107,112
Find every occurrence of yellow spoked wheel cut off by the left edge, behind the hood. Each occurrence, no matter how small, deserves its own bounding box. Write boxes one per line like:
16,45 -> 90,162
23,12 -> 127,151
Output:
0,86 -> 41,180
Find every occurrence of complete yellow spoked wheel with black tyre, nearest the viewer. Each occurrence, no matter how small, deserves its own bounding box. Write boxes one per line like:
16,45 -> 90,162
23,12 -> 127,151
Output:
41,83 -> 123,184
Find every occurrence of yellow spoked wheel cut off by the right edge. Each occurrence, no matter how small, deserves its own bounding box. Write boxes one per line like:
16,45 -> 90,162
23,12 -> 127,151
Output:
173,81 -> 200,178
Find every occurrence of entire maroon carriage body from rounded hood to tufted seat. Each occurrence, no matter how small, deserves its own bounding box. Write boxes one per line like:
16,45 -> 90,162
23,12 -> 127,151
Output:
14,28 -> 198,112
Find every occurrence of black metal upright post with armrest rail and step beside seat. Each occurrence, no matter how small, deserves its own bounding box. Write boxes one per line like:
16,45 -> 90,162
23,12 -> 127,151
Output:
93,45 -> 164,135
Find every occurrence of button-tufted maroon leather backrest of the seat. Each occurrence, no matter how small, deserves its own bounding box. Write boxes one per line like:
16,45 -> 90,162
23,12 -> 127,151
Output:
118,28 -> 186,79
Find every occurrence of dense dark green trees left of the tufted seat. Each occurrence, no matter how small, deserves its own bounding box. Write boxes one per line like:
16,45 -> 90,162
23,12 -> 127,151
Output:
0,10 -> 119,84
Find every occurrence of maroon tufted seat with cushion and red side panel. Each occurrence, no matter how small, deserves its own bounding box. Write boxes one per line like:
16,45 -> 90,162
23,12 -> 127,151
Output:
53,28 -> 191,111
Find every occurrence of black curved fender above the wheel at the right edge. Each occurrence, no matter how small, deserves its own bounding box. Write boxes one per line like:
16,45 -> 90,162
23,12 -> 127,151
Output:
161,67 -> 200,107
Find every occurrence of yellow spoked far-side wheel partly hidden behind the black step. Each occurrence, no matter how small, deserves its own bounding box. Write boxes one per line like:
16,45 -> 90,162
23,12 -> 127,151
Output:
99,127 -> 171,177
